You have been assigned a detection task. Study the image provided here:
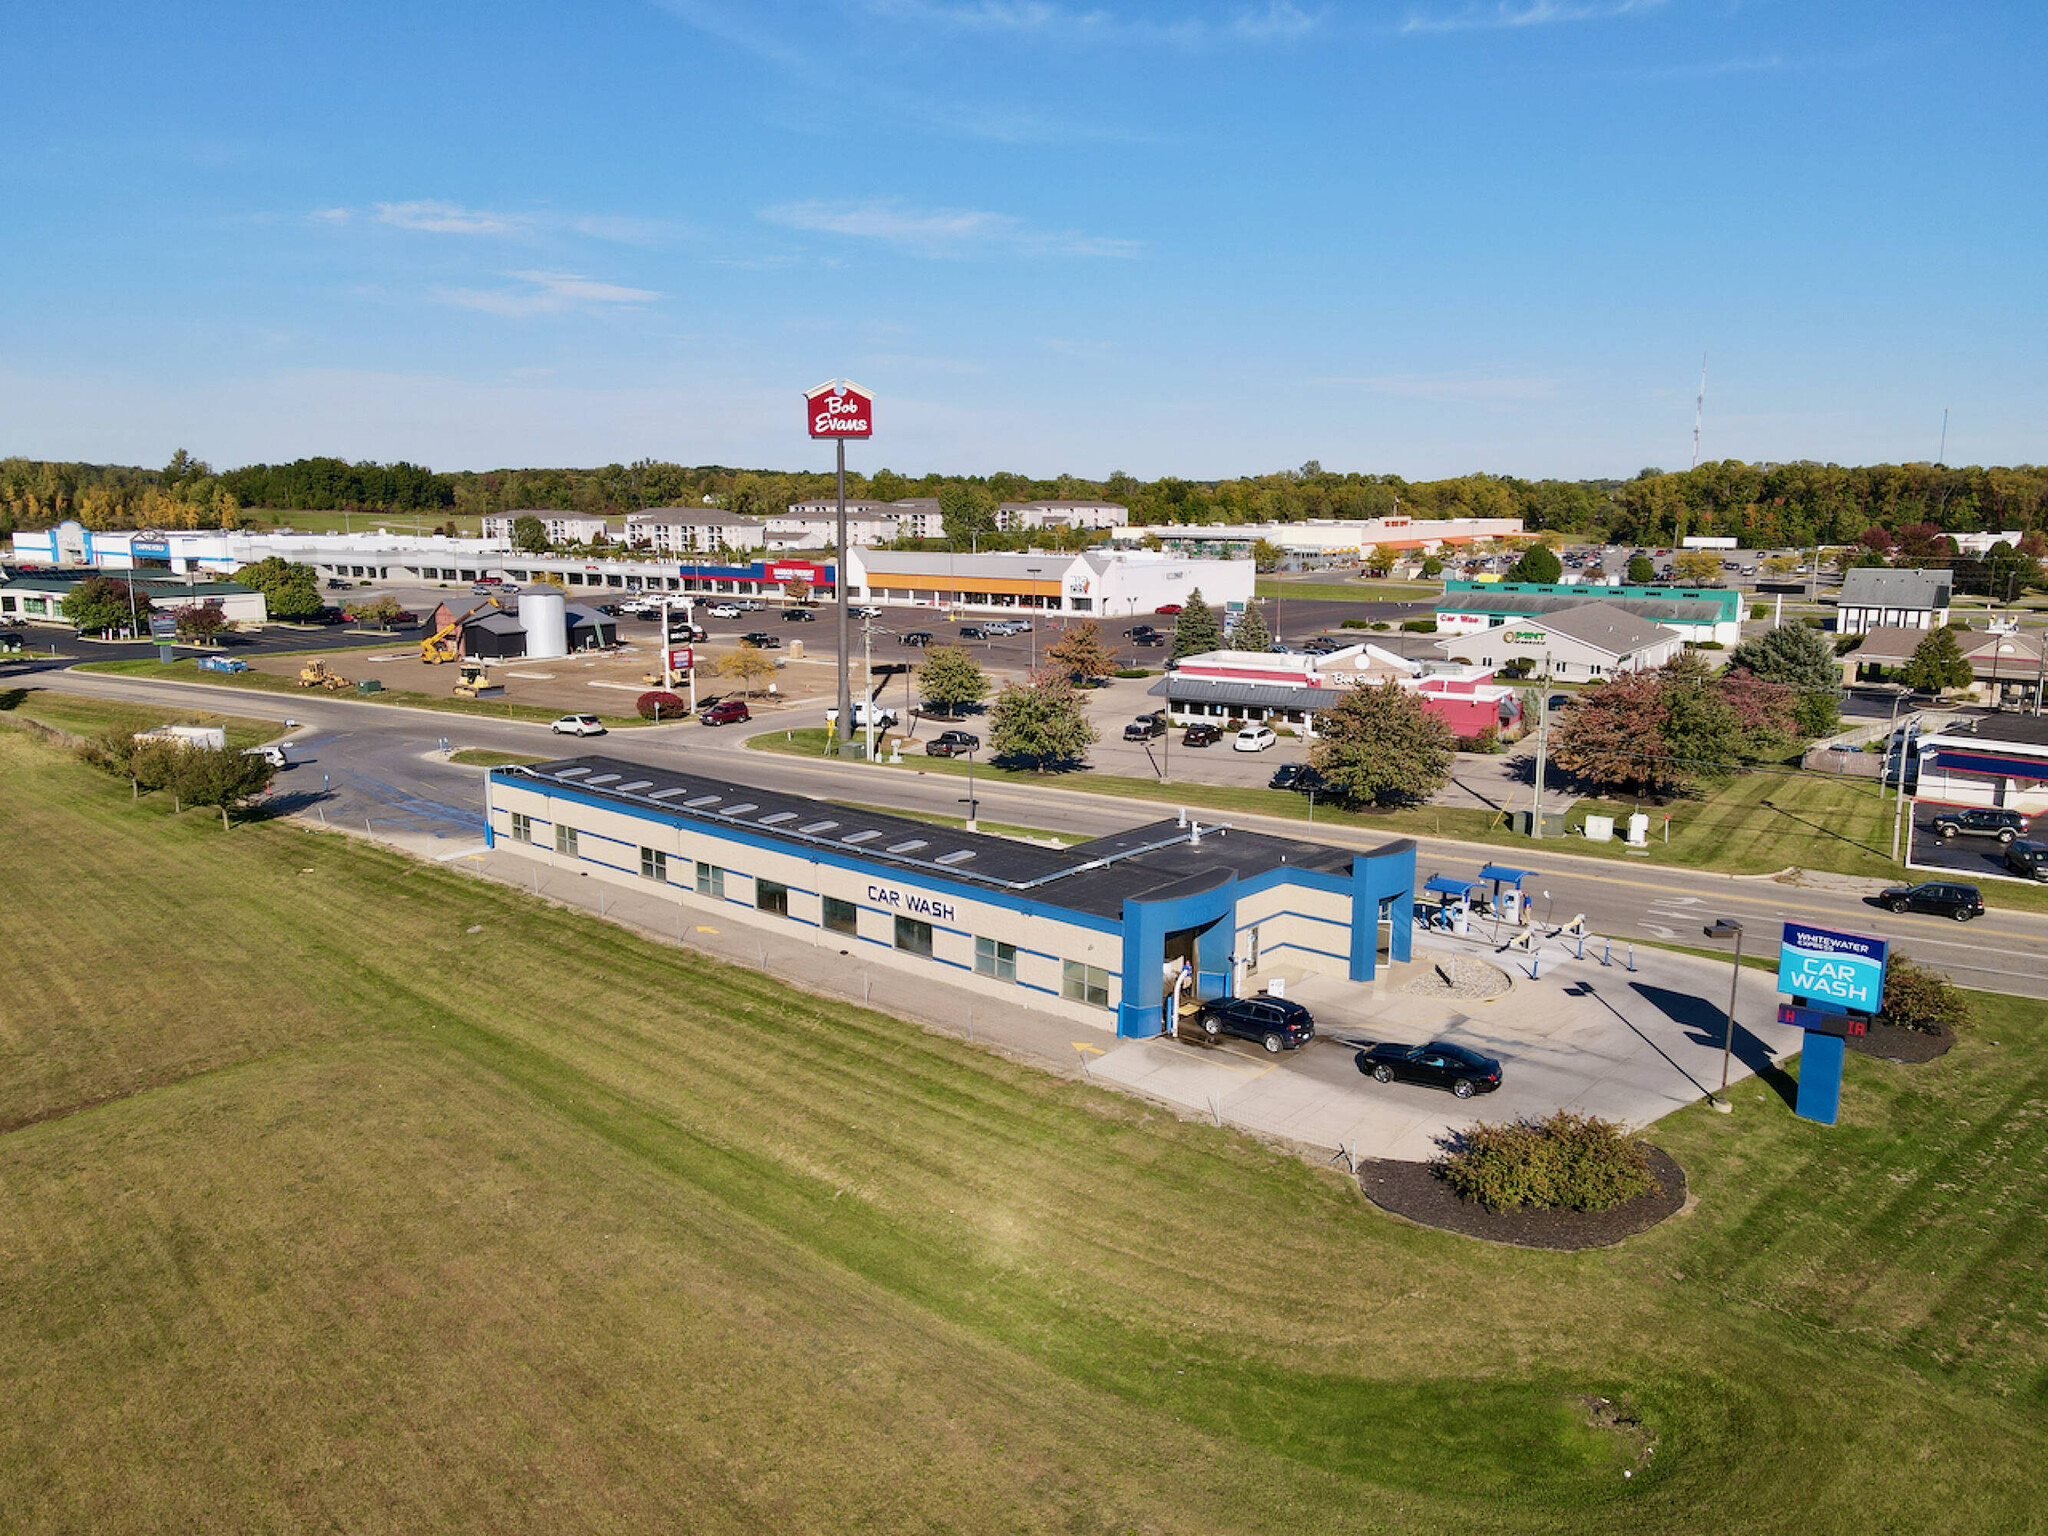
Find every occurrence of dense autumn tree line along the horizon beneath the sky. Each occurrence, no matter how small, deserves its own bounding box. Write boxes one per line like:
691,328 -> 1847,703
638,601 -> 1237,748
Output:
16,449 -> 2048,547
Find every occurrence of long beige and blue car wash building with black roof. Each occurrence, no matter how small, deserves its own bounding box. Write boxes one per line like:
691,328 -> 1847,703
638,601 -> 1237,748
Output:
485,756 -> 1415,1036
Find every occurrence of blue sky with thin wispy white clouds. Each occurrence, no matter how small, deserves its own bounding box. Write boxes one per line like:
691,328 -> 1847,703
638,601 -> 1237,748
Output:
0,0 -> 2048,477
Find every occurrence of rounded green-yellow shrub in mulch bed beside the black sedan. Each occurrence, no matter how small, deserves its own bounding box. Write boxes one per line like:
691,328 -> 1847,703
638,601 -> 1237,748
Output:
1436,1110 -> 1661,1210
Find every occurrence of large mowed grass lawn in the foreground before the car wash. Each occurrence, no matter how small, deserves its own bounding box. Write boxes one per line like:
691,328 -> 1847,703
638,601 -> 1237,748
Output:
0,731 -> 2048,1536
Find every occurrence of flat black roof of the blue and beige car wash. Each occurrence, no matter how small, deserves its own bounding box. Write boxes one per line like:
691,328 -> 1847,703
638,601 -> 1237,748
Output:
503,756 -> 1384,920
